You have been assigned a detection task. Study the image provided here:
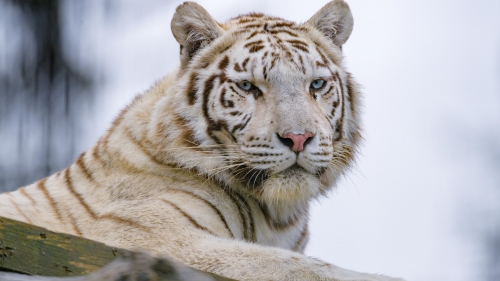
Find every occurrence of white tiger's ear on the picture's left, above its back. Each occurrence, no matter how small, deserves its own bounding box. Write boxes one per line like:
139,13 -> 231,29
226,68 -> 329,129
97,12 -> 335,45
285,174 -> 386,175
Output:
171,2 -> 223,68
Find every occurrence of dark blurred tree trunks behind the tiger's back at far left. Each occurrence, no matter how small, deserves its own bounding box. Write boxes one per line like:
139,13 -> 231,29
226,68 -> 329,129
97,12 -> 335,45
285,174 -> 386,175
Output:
0,0 -> 92,192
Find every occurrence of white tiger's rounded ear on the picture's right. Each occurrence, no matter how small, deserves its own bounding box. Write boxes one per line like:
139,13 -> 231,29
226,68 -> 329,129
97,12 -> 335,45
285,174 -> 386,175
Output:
307,0 -> 354,48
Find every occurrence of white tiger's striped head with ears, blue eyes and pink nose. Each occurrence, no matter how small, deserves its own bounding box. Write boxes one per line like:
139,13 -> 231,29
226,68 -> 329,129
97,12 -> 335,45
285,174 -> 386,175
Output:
151,0 -> 360,206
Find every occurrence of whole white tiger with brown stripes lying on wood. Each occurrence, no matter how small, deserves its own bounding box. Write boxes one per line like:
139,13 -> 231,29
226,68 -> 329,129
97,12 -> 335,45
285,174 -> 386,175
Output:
0,0 -> 401,281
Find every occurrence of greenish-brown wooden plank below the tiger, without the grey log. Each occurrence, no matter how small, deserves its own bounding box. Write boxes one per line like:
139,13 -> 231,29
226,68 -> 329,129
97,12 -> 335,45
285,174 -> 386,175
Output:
0,217 -> 127,276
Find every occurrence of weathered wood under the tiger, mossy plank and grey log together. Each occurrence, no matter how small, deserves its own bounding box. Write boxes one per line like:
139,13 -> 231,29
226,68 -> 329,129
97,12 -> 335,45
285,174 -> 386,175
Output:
0,217 -> 231,281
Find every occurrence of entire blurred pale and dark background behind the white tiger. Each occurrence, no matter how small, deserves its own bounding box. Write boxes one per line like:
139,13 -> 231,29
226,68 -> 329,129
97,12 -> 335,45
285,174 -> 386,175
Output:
0,0 -> 500,281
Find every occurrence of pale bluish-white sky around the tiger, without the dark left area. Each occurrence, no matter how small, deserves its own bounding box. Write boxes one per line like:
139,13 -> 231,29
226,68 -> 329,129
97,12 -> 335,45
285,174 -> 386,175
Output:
1,0 -> 500,281
